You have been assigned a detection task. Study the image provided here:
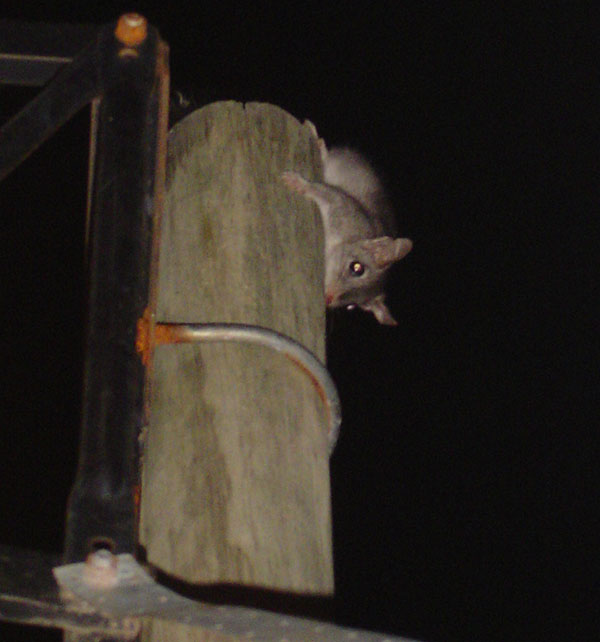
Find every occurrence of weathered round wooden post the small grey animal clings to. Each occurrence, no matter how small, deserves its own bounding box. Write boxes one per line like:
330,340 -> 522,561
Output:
140,102 -> 333,640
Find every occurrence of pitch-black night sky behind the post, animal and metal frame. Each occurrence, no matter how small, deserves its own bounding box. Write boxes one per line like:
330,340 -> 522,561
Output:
0,1 -> 599,642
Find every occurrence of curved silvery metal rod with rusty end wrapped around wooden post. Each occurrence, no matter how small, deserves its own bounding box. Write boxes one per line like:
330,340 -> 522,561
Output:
155,323 -> 342,455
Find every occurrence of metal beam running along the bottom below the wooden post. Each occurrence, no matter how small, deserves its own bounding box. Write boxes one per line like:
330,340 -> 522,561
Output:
0,547 -> 420,642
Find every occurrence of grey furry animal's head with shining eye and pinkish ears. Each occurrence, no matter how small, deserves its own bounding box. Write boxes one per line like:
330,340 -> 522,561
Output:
325,236 -> 412,325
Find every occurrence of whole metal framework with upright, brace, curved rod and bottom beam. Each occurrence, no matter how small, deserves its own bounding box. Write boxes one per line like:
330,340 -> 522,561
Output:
0,14 -> 408,642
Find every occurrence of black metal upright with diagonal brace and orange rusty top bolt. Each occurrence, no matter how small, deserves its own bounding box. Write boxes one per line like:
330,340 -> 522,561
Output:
0,14 -> 169,562
